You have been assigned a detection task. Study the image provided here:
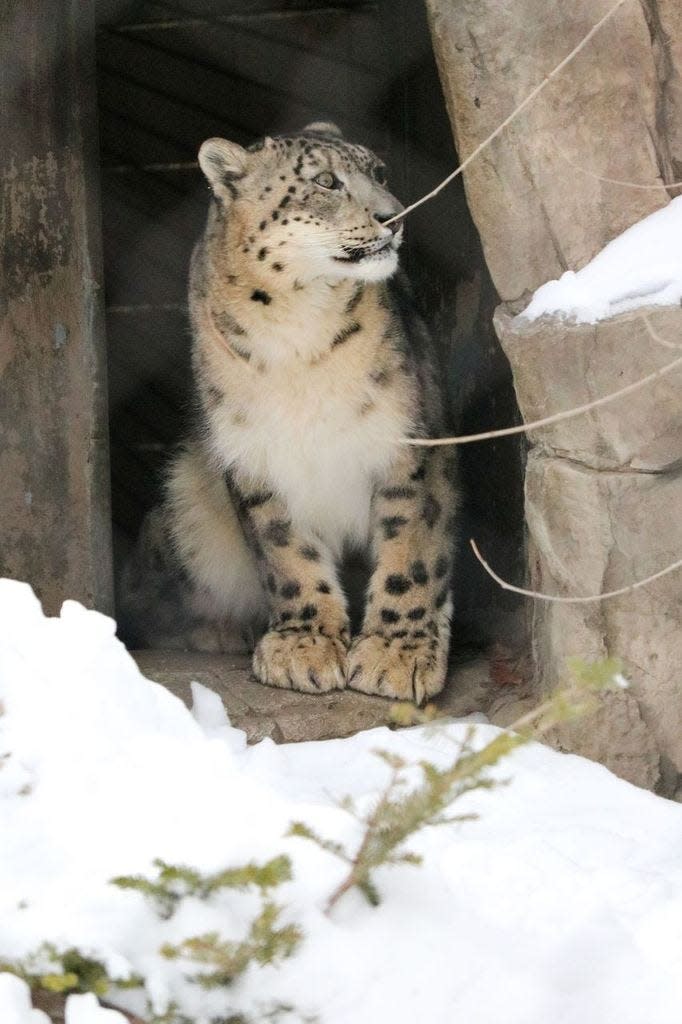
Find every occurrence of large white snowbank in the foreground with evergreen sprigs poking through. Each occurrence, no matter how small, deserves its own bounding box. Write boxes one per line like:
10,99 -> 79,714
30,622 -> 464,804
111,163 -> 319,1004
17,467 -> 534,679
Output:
0,581 -> 682,1024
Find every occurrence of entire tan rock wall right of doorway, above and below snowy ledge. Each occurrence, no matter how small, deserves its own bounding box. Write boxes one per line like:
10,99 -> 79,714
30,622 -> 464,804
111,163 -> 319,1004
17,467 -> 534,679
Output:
426,0 -> 682,794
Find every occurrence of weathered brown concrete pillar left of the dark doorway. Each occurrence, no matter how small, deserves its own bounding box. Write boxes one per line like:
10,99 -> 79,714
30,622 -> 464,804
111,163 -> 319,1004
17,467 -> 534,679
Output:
0,0 -> 113,613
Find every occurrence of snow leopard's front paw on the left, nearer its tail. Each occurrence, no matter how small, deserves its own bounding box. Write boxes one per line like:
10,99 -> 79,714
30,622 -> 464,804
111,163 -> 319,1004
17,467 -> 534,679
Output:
253,630 -> 347,693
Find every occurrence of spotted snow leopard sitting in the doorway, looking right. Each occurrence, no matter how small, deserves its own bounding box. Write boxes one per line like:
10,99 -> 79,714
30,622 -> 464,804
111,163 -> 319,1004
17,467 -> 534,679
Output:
126,122 -> 458,703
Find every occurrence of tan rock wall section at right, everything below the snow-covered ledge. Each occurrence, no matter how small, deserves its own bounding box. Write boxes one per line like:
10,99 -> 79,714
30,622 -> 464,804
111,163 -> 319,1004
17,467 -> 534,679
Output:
495,308 -> 682,792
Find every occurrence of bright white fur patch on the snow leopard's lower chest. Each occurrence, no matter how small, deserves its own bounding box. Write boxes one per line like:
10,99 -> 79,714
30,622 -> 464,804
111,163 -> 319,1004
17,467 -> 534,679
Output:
204,351 -> 410,553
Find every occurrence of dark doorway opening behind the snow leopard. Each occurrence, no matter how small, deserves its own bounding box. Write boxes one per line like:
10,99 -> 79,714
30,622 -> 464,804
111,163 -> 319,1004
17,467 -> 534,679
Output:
97,0 -> 522,643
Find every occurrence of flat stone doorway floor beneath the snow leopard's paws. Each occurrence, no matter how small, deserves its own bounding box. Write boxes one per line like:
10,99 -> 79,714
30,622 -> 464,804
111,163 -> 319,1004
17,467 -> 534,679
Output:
134,651 -> 494,742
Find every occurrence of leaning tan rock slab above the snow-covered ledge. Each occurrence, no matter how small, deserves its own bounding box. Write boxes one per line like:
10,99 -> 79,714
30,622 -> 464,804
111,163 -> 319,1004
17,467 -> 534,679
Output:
427,0 -> 667,300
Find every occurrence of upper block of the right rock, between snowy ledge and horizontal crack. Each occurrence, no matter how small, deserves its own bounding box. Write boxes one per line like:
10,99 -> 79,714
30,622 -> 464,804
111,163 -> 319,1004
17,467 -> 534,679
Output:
495,306 -> 682,472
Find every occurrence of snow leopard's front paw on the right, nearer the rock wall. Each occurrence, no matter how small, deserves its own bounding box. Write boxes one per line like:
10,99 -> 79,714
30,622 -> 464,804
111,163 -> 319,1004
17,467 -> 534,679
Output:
347,633 -> 446,705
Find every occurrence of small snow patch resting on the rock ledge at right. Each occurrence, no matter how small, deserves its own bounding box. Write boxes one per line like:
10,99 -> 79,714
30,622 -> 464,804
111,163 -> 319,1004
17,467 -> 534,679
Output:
520,197 -> 682,324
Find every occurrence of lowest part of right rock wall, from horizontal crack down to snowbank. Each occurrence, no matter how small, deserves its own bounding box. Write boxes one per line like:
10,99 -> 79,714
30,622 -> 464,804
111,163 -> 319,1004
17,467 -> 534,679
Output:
526,451 -> 682,786
